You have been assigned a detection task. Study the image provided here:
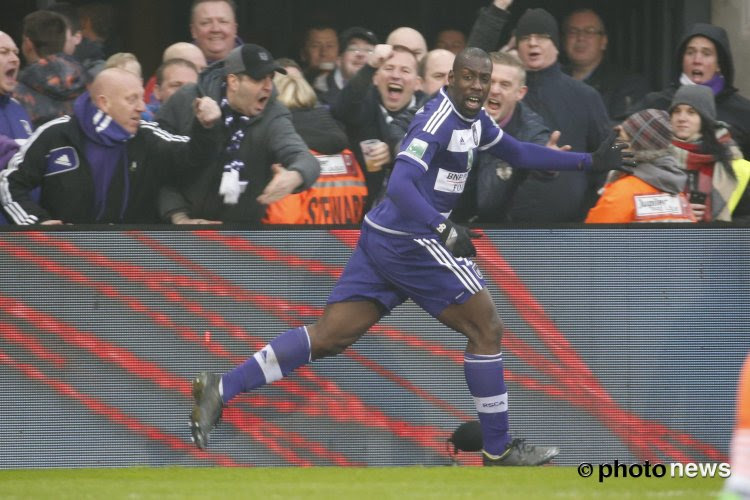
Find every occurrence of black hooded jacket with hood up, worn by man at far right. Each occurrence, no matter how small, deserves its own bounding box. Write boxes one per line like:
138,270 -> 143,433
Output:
631,23 -> 750,157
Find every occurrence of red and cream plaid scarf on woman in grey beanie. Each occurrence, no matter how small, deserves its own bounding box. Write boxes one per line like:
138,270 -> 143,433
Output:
669,127 -> 742,222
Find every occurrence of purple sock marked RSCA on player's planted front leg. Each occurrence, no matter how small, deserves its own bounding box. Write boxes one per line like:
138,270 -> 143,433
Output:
464,353 -> 510,455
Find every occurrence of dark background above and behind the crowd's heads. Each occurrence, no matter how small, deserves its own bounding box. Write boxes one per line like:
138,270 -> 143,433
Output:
0,0 -> 711,89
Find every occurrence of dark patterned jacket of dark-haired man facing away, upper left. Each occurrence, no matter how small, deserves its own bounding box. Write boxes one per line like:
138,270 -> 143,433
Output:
13,53 -> 88,128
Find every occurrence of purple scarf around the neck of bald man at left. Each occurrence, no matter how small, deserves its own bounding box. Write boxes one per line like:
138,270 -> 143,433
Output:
73,91 -> 134,221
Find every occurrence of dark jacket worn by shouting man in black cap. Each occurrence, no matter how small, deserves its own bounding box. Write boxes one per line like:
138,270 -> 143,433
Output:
157,57 -> 320,225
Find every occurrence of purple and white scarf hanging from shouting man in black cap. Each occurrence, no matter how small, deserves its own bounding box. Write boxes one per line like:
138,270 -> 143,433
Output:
219,82 -> 251,205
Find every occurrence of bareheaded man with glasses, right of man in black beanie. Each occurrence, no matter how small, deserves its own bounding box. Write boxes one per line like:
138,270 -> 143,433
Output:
563,9 -> 648,122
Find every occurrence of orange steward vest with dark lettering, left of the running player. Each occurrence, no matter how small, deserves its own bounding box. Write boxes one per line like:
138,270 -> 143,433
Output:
263,149 -> 367,224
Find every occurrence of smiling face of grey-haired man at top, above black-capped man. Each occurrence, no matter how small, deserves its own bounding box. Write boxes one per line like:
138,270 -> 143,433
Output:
190,0 -> 242,64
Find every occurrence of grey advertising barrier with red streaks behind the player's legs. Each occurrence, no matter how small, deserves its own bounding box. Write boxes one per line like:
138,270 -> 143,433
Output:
0,227 -> 750,468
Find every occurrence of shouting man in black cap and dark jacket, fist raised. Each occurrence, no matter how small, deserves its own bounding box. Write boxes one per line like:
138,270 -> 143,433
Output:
159,44 -> 320,225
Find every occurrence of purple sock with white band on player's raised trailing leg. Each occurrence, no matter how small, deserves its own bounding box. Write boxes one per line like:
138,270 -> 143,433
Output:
221,326 -> 311,404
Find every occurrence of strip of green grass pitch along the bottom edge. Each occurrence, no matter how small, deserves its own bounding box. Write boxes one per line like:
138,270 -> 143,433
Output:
0,467 -> 724,500
